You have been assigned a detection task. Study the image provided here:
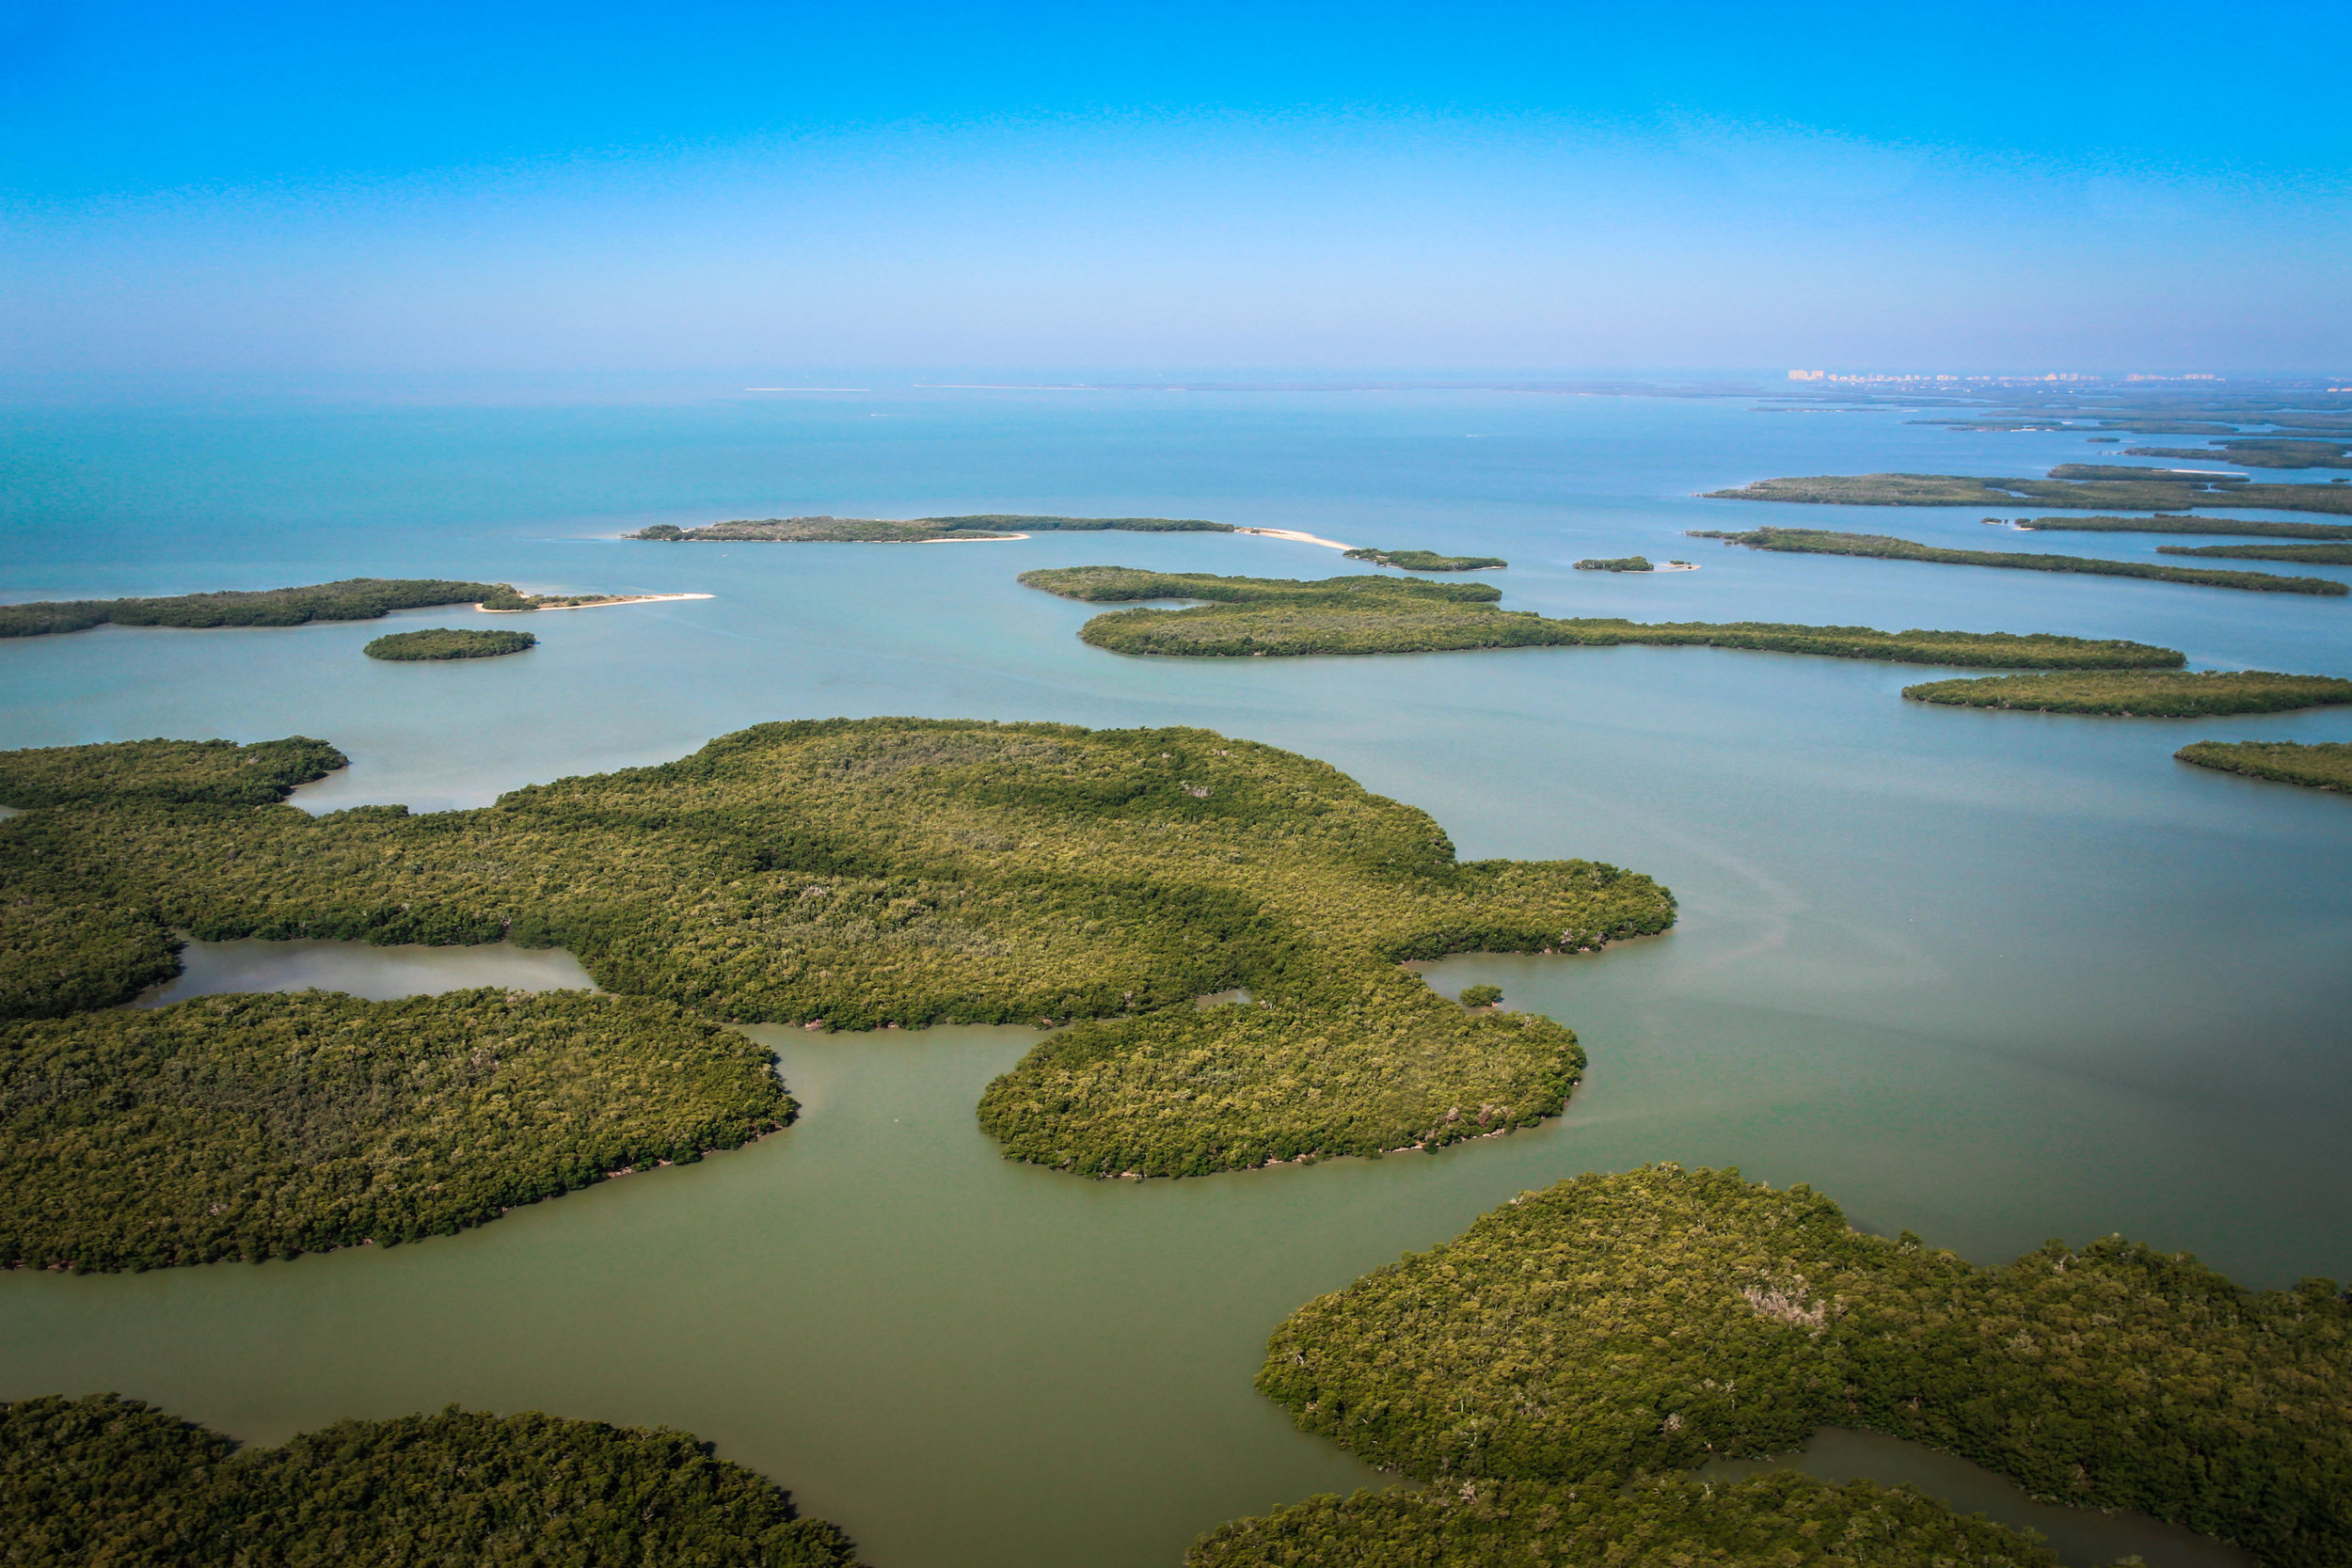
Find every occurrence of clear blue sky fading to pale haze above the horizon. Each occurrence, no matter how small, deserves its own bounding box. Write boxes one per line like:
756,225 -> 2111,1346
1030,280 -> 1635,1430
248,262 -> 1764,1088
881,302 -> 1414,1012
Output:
0,0 -> 2352,372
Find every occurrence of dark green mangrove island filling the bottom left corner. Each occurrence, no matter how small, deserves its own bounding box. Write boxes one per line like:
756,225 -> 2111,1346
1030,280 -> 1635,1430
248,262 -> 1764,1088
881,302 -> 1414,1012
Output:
0,1394 -> 856,1568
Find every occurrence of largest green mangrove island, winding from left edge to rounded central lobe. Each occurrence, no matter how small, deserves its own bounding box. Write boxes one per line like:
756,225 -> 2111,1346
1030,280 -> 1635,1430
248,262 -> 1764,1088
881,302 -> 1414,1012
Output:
0,723 -> 1675,1176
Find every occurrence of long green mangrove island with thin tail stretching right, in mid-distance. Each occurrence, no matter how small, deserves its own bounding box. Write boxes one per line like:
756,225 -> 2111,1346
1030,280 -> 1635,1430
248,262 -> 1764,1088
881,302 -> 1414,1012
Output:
1021,566 -> 2183,670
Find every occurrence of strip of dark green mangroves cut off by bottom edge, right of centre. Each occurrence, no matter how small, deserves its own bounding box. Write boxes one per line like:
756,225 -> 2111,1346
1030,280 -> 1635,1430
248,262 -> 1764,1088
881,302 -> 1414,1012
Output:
1185,1472 -> 2058,1568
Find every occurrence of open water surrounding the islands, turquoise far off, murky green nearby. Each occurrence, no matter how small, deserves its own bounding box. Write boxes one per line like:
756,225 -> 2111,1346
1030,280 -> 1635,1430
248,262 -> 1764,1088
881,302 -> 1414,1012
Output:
0,392 -> 2352,1568
